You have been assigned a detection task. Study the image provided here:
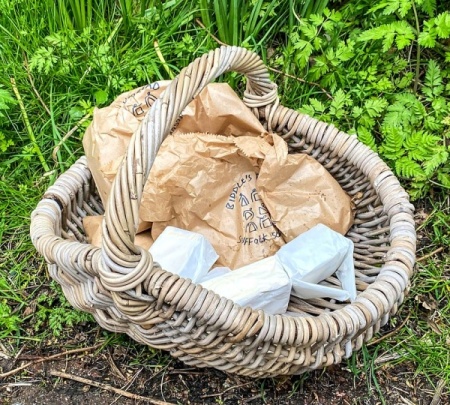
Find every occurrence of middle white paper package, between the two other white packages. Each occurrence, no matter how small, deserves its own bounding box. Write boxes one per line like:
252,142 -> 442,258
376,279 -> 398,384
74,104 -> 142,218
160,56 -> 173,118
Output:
200,255 -> 292,315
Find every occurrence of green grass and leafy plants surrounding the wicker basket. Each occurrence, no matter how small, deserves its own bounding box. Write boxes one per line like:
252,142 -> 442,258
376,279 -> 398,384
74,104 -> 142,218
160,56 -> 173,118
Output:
0,0 -> 450,398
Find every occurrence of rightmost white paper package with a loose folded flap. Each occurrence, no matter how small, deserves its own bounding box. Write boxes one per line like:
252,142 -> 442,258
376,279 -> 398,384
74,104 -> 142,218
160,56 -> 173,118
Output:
276,224 -> 356,301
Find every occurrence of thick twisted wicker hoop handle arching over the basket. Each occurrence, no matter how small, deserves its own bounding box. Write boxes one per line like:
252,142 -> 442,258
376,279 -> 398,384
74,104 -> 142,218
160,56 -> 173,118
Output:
99,46 -> 278,294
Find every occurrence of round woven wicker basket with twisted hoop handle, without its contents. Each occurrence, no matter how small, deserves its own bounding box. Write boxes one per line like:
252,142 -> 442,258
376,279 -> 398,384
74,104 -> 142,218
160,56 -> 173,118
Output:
31,47 -> 416,377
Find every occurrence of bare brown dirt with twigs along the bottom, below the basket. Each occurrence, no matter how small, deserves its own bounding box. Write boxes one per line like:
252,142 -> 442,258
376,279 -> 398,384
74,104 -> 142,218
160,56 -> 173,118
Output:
0,330 -> 450,405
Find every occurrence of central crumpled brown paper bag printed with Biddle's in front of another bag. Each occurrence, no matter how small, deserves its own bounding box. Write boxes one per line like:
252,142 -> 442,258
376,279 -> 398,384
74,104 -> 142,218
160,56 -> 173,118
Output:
141,133 -> 284,269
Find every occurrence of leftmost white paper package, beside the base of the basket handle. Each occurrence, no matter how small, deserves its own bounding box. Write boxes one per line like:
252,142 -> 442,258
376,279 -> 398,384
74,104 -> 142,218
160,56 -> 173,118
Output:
149,226 -> 219,282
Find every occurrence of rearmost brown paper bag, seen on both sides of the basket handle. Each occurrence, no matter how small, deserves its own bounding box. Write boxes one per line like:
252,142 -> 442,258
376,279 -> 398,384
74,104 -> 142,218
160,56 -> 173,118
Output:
83,81 -> 264,205
